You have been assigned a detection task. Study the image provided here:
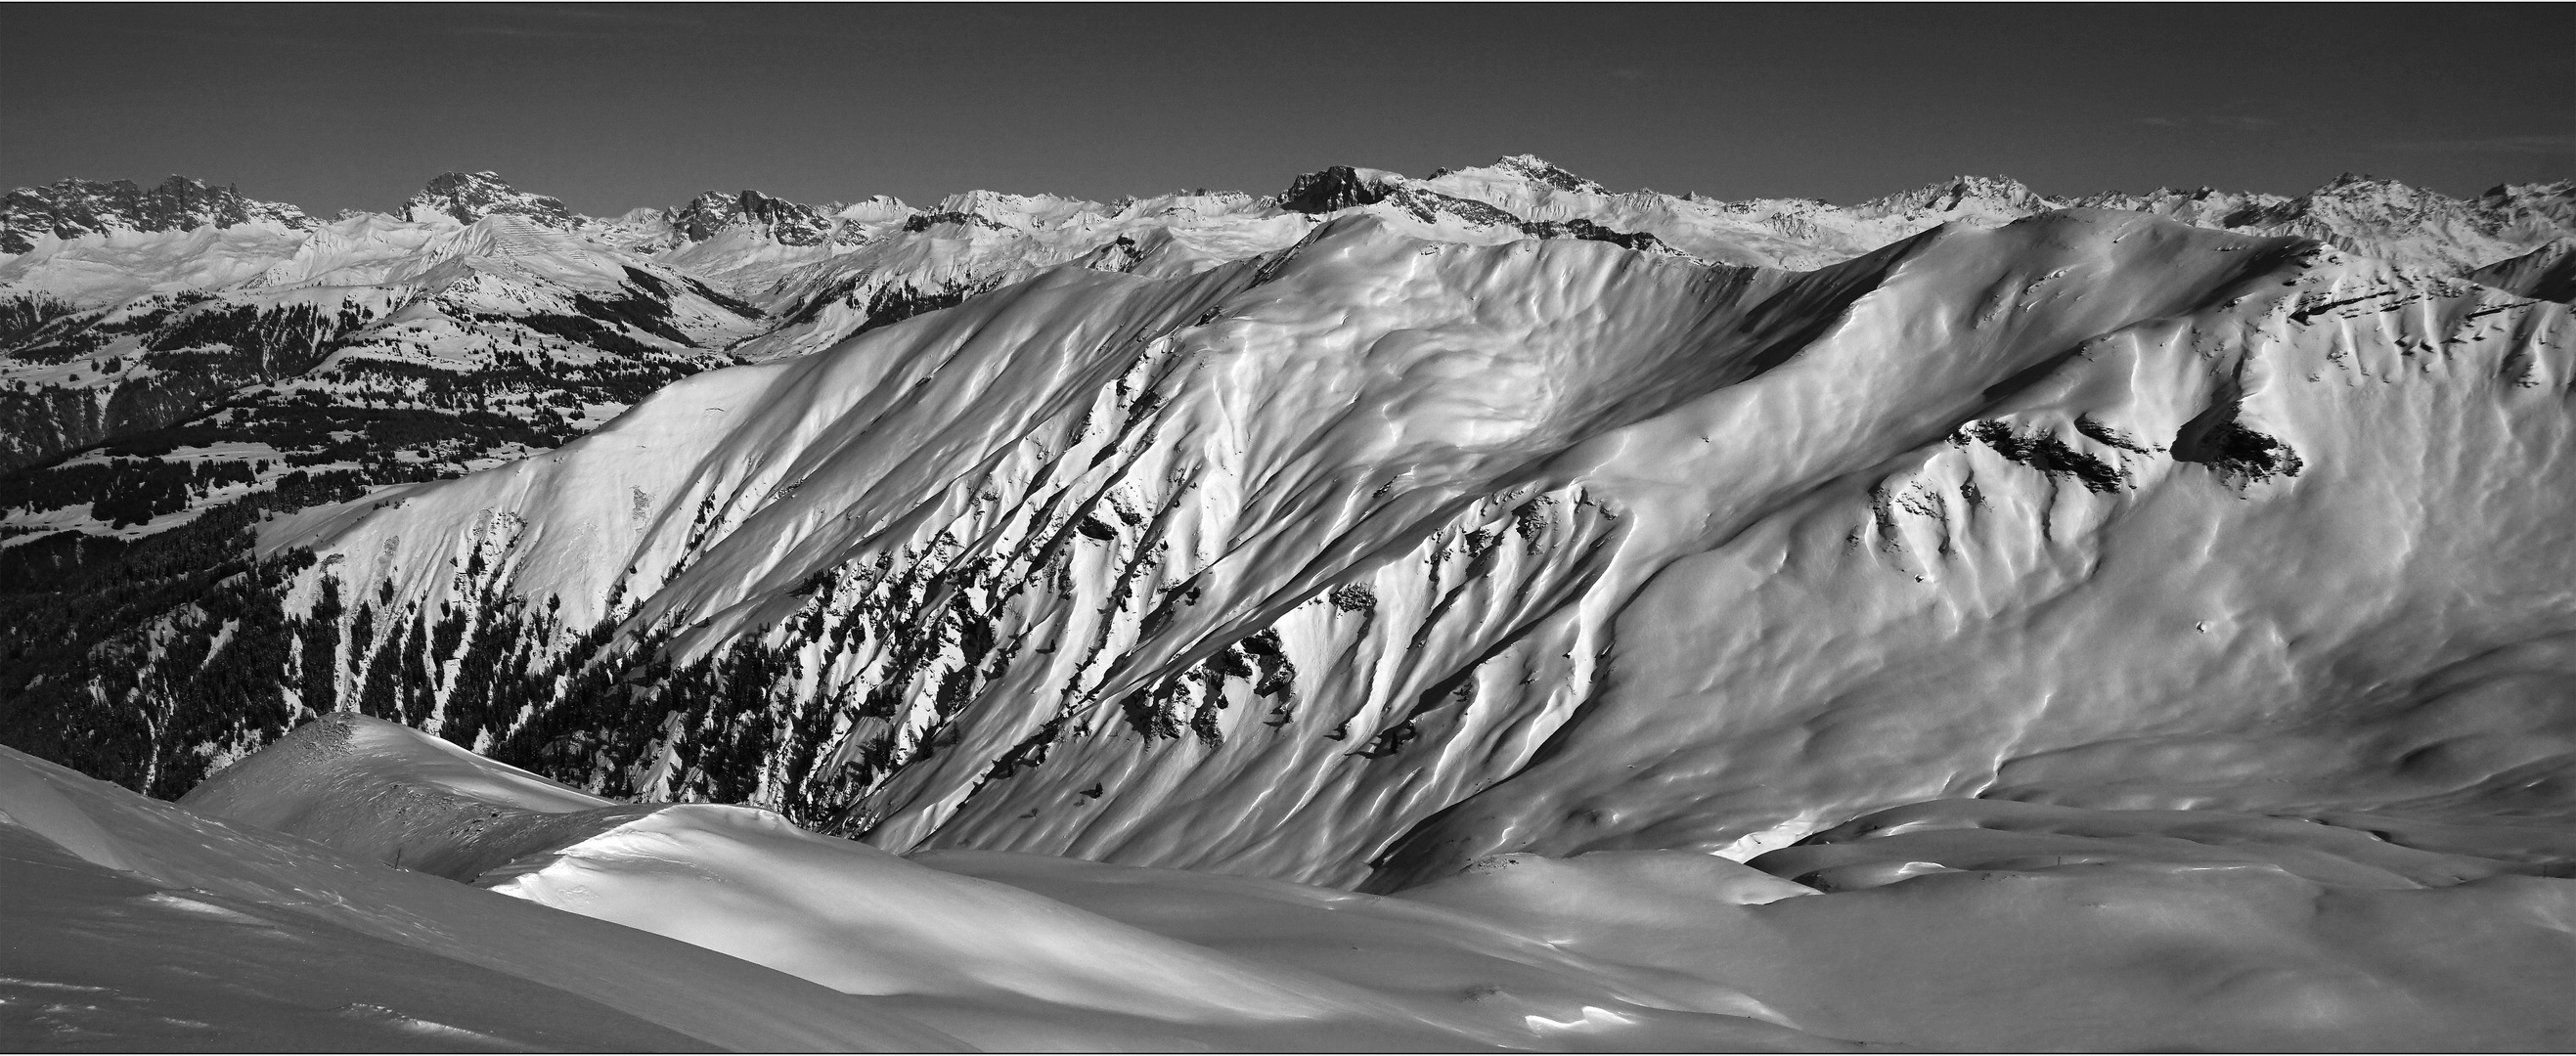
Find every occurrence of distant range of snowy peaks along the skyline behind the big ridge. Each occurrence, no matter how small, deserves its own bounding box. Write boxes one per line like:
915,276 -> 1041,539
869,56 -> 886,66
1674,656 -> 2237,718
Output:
0,157 -> 2576,492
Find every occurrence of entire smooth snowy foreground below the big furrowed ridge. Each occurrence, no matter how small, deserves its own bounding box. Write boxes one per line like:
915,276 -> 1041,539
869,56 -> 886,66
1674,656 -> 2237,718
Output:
0,716 -> 2576,1051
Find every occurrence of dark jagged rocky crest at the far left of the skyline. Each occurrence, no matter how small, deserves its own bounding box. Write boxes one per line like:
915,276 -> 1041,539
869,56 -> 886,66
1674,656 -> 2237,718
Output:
0,175 -> 314,252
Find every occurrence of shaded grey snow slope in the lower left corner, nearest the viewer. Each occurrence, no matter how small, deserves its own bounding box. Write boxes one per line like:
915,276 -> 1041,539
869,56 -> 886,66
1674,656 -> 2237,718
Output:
0,747 -> 955,1051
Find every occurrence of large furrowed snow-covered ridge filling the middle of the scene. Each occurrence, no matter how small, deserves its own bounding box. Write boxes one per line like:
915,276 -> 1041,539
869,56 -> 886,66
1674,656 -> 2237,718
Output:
250,211 -> 2576,906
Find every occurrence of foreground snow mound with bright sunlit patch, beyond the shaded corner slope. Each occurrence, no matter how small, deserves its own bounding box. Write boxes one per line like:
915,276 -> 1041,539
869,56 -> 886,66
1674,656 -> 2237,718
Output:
151,716 -> 1849,1051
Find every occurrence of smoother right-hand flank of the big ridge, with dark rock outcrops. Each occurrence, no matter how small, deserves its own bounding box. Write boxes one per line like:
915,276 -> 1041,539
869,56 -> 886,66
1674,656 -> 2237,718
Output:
1394,242 -> 2576,876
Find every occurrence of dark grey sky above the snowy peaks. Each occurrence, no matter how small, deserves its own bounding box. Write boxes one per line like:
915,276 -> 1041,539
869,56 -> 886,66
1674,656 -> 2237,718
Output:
0,3 -> 2576,214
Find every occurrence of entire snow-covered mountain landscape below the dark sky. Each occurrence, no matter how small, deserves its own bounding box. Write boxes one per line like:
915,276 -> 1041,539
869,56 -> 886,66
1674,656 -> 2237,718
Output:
0,157 -> 2576,1051
